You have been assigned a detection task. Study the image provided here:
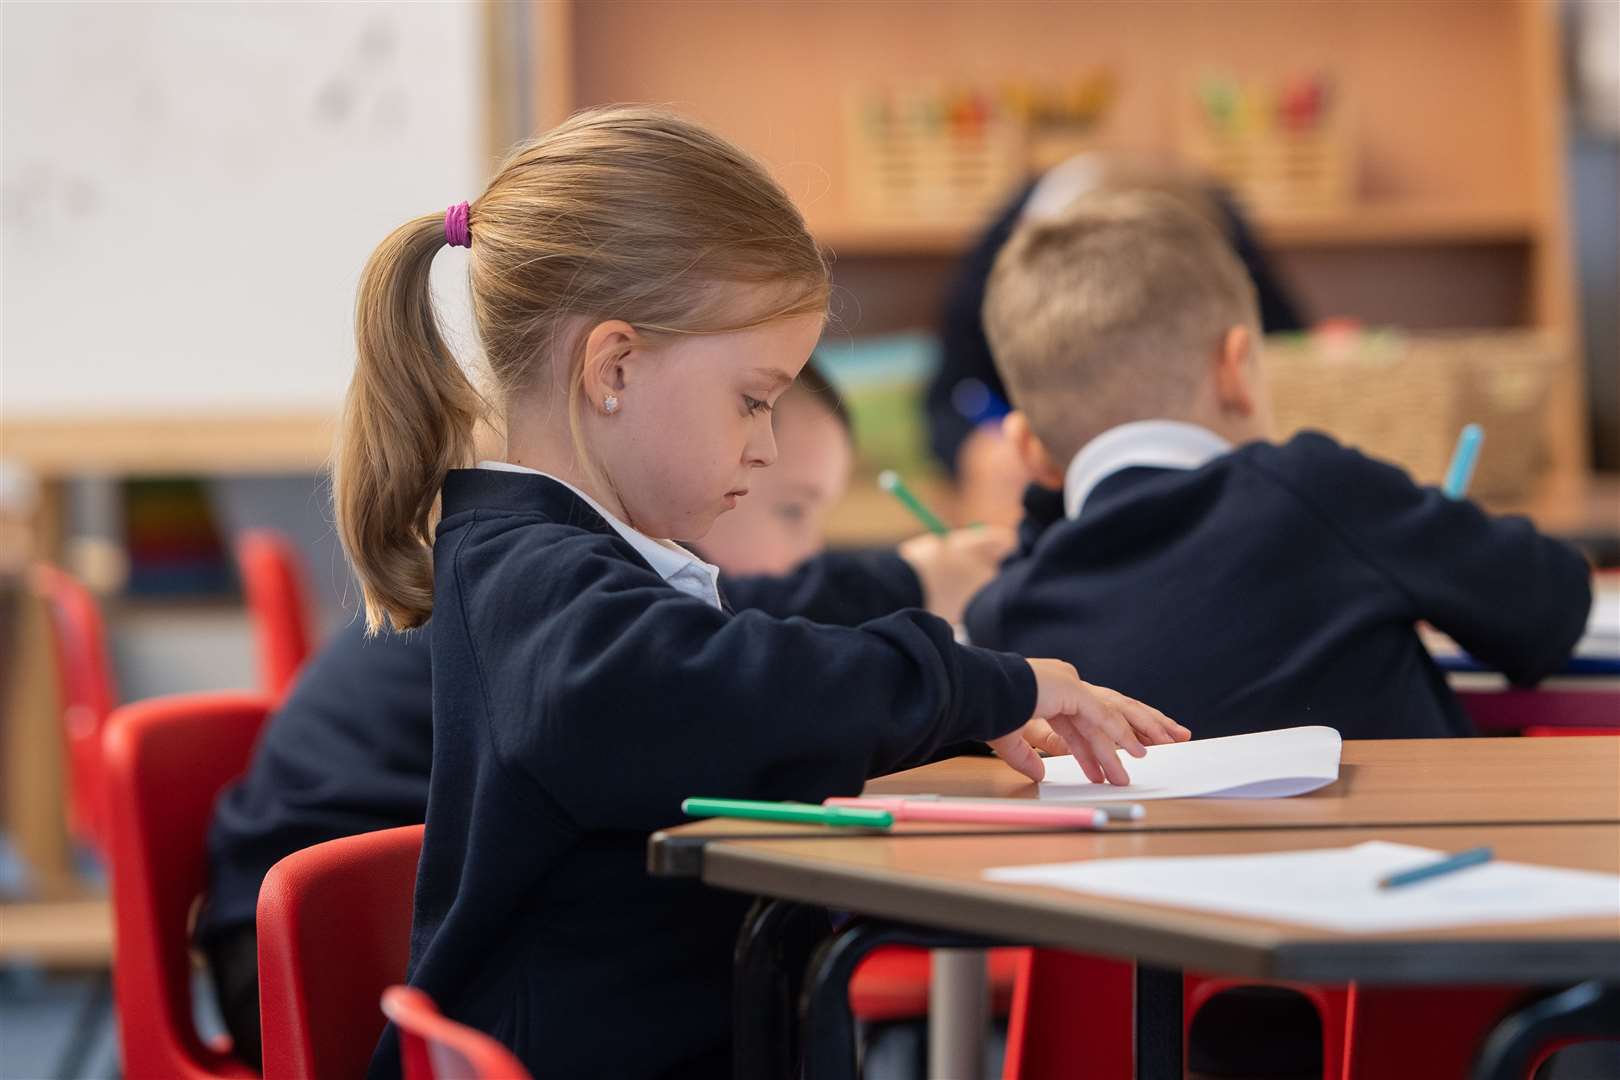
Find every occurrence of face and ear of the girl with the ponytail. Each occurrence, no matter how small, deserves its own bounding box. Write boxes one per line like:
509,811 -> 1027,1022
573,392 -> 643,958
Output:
585,306 -> 823,541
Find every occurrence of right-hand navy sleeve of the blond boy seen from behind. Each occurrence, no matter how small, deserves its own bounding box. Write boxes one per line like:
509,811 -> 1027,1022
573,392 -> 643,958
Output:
1246,432 -> 1591,685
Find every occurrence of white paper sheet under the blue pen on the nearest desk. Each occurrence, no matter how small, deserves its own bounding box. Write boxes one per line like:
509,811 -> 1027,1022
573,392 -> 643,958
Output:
985,840 -> 1620,933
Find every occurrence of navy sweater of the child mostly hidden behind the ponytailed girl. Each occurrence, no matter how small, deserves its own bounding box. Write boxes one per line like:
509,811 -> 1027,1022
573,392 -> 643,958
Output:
196,551 -> 923,944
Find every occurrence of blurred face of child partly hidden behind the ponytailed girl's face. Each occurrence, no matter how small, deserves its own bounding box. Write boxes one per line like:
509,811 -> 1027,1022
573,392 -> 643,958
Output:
700,359 -> 855,575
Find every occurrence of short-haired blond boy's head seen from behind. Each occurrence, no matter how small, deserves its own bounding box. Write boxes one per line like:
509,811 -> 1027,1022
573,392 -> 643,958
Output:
983,191 -> 1268,487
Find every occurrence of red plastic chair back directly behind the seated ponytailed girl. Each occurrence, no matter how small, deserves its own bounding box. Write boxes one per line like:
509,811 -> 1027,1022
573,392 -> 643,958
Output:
258,826 -> 423,1080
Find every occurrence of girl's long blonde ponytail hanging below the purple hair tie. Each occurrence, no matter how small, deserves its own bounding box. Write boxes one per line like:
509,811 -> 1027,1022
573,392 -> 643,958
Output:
334,214 -> 483,633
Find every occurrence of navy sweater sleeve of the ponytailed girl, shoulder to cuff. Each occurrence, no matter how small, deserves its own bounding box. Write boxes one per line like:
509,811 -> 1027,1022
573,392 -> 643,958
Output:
439,520 -> 1035,831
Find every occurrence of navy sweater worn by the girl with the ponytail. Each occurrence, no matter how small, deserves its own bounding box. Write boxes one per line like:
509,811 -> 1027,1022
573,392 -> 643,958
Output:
371,470 -> 1035,1080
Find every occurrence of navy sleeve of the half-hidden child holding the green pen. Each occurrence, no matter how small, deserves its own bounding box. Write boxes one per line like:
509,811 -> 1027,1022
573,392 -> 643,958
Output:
721,551 -> 923,627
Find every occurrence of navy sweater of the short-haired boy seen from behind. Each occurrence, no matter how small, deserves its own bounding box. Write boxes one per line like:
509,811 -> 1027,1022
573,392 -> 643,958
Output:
966,434 -> 1591,738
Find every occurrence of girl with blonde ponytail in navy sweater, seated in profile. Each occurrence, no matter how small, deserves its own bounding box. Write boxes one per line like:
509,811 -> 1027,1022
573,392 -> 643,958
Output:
335,108 -> 1186,1078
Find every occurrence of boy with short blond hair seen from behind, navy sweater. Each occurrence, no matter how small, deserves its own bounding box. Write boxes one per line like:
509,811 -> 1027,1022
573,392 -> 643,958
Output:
966,194 -> 1591,738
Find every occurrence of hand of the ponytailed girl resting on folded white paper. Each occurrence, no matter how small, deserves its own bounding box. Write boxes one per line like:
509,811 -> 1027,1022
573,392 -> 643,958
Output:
990,661 -> 1192,784
